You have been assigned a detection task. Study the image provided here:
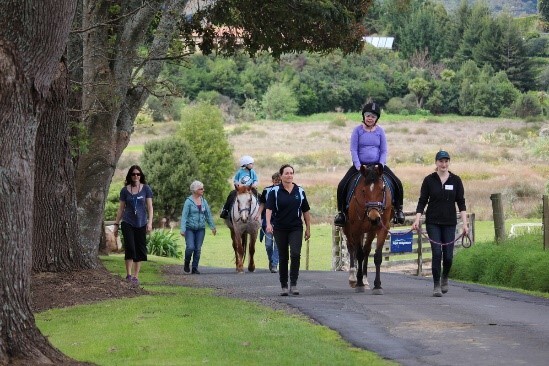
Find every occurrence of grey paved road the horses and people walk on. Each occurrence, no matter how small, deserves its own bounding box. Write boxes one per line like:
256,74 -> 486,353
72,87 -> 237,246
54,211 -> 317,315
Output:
170,266 -> 549,366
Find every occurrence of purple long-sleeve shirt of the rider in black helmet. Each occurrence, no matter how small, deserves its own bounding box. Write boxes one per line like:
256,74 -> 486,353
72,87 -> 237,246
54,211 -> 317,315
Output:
351,125 -> 387,169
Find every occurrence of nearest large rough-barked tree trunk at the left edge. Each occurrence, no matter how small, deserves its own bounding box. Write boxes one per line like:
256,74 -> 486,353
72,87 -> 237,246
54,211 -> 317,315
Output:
0,0 -> 81,365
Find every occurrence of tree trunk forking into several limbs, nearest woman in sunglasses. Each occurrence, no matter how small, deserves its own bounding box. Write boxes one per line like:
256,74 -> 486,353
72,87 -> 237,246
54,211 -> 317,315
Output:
75,0 -> 187,257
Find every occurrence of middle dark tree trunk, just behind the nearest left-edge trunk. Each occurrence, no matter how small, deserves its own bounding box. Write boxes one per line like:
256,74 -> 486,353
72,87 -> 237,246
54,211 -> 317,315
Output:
32,62 -> 92,272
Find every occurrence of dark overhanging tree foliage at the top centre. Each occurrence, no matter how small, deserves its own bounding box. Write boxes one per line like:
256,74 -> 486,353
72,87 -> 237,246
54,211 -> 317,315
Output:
193,0 -> 372,58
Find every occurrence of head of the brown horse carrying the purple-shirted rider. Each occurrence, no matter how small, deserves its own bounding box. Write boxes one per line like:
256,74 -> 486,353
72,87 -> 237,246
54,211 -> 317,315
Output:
360,164 -> 387,224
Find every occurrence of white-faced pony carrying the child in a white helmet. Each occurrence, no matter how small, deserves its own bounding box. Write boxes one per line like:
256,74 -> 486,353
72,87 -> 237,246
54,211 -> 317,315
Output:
225,186 -> 261,273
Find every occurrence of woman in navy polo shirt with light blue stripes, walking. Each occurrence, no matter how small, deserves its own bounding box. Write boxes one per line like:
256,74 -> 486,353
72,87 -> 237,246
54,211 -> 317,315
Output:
265,164 -> 311,296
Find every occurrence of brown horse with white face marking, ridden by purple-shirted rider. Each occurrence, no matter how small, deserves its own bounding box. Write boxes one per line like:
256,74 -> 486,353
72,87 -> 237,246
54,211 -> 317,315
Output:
343,164 -> 393,295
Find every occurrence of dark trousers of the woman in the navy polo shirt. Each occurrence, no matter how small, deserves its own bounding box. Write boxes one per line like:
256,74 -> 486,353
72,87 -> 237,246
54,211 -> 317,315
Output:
274,228 -> 303,288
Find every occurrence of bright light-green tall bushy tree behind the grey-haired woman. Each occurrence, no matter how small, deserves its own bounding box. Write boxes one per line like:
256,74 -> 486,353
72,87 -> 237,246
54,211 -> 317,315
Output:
178,103 -> 234,210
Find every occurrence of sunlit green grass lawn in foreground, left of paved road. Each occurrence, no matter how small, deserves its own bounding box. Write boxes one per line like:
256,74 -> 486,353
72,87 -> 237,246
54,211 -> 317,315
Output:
35,255 -> 394,365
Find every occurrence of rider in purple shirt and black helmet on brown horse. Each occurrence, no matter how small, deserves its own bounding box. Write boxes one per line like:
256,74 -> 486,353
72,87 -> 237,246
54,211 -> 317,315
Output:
334,102 -> 404,226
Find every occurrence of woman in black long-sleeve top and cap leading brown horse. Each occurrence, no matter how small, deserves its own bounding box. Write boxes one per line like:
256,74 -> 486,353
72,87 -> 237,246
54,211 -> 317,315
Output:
412,150 -> 469,297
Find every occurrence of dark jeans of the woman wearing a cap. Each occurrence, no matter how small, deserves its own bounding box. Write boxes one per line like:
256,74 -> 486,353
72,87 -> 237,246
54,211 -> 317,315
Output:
426,224 -> 456,285
